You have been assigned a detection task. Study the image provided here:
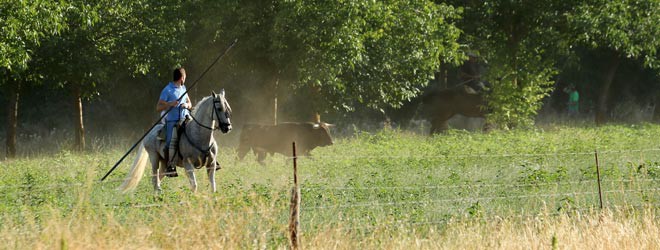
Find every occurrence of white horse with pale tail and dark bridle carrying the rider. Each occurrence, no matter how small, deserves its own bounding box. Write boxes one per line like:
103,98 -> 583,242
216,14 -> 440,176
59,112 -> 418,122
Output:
119,90 -> 232,193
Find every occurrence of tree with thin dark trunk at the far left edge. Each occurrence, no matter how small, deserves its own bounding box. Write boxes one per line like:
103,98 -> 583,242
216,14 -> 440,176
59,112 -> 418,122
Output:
0,0 -> 64,157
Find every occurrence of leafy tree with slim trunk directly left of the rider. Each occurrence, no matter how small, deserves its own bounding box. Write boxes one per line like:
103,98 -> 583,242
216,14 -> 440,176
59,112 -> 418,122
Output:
37,0 -> 185,150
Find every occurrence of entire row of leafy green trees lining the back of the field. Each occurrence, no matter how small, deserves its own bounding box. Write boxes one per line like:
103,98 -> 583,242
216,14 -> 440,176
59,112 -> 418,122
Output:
0,0 -> 660,157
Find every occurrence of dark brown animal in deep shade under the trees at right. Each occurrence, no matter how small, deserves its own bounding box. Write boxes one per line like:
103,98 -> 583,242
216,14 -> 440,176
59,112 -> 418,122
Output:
422,84 -> 487,134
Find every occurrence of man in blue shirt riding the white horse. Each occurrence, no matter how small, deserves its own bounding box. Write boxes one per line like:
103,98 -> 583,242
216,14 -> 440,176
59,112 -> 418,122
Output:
156,67 -> 192,177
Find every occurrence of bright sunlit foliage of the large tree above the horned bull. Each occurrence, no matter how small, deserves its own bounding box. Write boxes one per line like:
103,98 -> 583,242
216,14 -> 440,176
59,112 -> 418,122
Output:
292,1 -> 460,109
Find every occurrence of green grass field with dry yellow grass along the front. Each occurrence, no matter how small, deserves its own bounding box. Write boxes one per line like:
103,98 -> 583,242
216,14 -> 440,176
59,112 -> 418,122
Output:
0,124 -> 660,249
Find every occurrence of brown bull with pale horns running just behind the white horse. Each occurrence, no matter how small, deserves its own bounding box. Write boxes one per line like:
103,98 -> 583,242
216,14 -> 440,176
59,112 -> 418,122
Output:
238,122 -> 333,162
